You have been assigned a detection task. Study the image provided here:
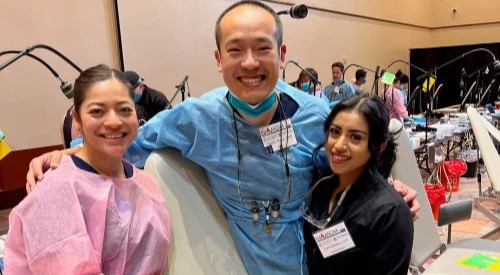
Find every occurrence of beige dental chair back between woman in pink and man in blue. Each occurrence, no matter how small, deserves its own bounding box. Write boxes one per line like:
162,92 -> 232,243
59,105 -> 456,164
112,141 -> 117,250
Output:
144,148 -> 247,275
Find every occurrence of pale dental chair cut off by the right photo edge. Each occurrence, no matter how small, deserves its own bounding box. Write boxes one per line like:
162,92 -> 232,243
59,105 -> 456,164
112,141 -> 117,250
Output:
467,107 -> 500,238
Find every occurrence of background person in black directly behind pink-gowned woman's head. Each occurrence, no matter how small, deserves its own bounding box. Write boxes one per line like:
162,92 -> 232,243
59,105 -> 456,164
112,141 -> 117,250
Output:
124,71 -> 168,125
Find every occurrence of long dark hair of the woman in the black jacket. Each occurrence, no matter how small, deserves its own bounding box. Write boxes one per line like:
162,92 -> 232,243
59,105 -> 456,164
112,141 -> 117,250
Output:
324,94 -> 397,178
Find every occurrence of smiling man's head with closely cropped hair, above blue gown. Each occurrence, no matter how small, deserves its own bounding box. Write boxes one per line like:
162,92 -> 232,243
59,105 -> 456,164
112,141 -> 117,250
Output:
215,5 -> 286,105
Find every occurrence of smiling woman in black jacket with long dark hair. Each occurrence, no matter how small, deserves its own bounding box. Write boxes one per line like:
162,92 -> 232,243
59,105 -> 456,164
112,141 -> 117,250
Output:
304,95 -> 413,275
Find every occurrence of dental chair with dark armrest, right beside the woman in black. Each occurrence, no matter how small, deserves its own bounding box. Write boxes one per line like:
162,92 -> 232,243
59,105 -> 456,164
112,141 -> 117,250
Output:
389,119 -> 500,275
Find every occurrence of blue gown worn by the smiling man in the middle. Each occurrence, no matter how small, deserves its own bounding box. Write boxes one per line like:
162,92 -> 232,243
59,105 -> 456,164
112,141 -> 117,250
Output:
126,81 -> 329,274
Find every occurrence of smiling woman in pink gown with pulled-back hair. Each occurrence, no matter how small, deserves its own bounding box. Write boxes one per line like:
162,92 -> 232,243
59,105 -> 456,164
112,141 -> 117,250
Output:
5,65 -> 170,274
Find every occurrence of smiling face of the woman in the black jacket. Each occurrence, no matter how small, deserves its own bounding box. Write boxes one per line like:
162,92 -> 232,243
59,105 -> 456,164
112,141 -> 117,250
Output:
325,110 -> 371,184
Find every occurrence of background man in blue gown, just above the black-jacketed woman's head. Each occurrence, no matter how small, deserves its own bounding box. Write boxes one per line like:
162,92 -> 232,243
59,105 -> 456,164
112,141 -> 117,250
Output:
323,62 -> 355,108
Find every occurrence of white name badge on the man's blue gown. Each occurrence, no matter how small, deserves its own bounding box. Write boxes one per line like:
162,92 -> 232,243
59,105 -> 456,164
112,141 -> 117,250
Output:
259,118 -> 297,154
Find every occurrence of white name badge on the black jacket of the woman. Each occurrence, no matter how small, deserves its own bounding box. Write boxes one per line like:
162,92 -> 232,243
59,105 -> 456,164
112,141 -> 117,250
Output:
313,222 -> 356,259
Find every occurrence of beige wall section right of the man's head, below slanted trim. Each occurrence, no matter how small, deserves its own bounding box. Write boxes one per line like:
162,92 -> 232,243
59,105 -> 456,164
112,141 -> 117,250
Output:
284,7 -> 430,83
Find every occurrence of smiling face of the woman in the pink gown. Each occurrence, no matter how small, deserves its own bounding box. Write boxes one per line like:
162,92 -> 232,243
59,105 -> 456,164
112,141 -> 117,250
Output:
76,78 -> 139,159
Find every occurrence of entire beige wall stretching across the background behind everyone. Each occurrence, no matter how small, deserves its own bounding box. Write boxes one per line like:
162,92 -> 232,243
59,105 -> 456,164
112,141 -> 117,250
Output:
0,0 -> 500,150
